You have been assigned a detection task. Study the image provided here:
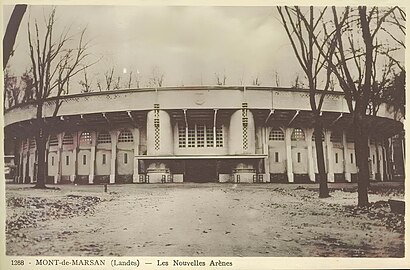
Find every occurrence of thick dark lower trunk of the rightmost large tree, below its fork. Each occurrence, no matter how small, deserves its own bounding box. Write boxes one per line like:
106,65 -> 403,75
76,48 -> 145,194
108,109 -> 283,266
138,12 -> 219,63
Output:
353,113 -> 370,206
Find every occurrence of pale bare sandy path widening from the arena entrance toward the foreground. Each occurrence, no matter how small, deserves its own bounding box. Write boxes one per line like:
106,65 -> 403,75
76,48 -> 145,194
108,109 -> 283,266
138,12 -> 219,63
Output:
7,184 -> 404,257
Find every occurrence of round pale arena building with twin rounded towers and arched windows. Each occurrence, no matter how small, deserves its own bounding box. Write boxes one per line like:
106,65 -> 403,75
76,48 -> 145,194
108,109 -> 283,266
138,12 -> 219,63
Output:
4,86 -> 403,184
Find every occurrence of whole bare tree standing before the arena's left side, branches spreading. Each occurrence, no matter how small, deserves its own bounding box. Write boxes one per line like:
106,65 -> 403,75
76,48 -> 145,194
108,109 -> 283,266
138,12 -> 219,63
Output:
28,9 -> 95,188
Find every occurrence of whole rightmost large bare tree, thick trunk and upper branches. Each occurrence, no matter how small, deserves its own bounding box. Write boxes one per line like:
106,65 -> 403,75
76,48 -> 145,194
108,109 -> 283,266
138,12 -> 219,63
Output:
325,6 -> 406,206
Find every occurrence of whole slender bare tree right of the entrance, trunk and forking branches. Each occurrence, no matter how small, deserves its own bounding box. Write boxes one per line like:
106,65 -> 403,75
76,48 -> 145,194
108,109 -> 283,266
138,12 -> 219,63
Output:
277,6 -> 335,198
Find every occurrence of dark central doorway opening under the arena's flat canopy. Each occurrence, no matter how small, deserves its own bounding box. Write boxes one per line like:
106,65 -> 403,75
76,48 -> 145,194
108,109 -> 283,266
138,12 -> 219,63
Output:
184,159 -> 218,183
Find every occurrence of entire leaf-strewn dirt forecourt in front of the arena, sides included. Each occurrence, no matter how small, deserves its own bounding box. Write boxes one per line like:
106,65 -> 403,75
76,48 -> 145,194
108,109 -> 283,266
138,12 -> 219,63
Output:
6,183 -> 404,257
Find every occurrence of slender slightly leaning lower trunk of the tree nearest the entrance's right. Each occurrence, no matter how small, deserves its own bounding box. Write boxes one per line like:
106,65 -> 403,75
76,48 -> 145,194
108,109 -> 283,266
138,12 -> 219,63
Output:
313,122 -> 330,198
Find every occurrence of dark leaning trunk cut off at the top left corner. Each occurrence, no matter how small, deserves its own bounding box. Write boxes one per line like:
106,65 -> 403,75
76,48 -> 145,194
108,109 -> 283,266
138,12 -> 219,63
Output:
3,5 -> 27,70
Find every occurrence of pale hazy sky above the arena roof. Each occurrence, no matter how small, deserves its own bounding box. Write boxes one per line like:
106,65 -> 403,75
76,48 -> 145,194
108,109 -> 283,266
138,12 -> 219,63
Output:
3,6 -> 406,93
